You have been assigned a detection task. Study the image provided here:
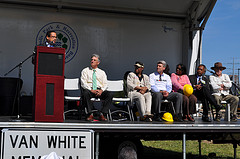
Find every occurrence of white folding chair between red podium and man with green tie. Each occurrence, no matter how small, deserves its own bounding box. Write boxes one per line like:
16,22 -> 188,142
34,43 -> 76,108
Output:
63,78 -> 81,120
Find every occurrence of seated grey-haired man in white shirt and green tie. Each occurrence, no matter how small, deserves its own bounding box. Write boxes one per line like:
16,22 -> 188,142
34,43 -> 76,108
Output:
81,54 -> 112,121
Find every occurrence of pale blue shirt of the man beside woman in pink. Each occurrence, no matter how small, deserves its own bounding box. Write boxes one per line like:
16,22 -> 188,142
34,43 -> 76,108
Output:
149,72 -> 172,93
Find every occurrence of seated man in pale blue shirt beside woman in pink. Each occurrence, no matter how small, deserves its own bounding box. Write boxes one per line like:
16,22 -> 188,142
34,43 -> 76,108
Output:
149,61 -> 183,121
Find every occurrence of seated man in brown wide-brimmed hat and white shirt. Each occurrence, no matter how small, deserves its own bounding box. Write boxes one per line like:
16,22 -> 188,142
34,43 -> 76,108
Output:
210,62 -> 239,121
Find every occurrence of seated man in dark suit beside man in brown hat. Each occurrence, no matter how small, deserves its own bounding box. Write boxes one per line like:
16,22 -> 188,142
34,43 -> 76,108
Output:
189,64 -> 221,122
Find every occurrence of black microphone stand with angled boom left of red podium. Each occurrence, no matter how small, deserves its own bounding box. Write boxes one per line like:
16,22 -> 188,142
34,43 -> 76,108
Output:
4,52 -> 34,121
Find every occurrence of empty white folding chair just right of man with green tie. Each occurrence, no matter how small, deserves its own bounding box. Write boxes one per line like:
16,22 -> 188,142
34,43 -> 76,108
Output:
107,80 -> 134,121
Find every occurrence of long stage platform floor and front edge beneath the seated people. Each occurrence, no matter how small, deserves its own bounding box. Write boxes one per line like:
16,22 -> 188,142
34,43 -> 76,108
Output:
0,116 -> 240,133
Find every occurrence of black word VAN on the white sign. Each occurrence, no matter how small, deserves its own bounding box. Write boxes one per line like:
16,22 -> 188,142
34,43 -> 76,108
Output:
10,135 -> 38,148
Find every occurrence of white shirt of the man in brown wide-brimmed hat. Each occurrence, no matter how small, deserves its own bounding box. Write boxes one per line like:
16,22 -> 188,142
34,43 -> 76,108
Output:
210,74 -> 232,96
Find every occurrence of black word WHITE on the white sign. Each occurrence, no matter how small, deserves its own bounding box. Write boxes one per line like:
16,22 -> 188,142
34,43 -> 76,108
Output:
47,136 -> 86,149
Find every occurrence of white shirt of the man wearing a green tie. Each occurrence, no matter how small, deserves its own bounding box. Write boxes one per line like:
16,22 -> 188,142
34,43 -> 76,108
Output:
81,67 -> 107,91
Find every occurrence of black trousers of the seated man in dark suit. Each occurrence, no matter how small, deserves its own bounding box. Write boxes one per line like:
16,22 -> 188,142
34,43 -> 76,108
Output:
194,86 -> 218,115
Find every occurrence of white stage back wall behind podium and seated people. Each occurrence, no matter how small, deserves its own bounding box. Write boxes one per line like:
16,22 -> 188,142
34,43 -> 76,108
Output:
0,8 -> 183,95
